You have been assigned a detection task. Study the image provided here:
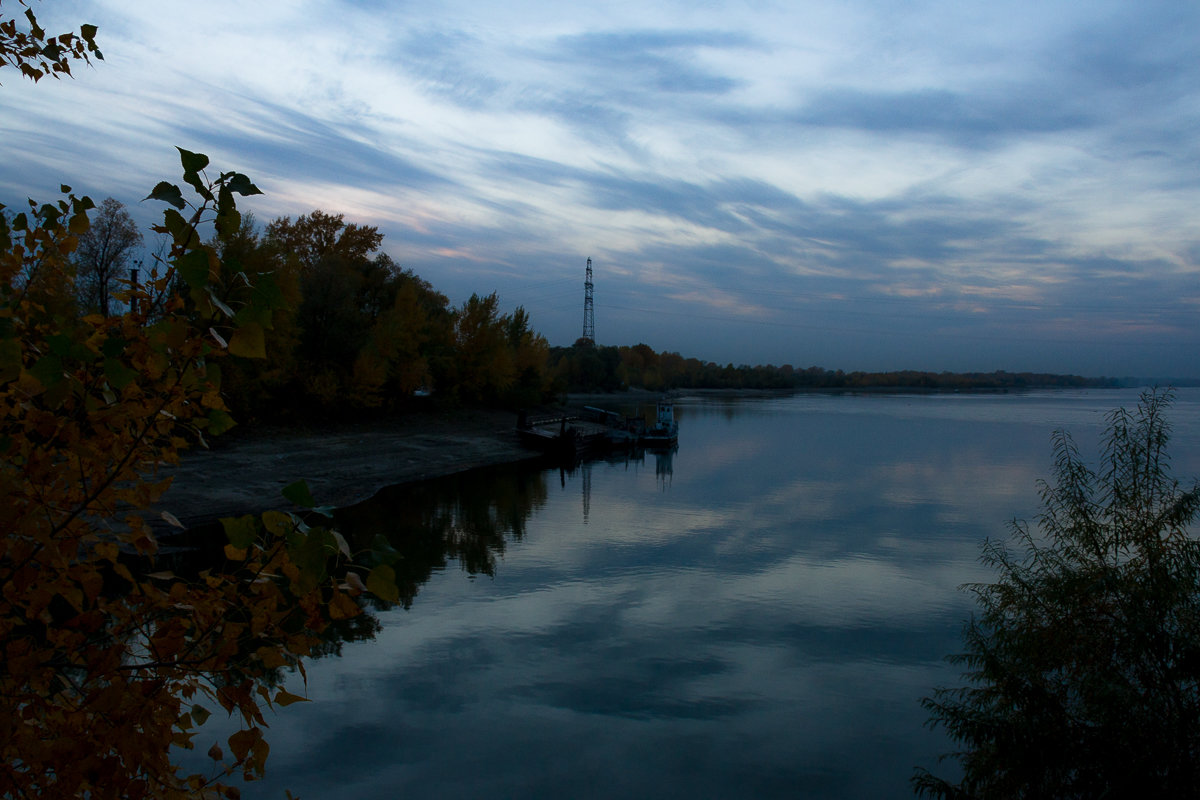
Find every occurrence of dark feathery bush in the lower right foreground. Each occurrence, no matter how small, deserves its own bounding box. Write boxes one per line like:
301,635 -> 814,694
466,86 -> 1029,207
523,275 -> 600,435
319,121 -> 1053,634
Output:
913,391 -> 1200,798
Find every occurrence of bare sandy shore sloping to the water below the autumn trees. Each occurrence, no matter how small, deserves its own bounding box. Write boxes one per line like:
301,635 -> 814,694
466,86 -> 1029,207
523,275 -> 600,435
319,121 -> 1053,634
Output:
152,410 -> 538,527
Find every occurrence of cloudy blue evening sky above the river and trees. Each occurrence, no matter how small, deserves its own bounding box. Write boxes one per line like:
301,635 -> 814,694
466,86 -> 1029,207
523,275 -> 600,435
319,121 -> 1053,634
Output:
0,0 -> 1200,378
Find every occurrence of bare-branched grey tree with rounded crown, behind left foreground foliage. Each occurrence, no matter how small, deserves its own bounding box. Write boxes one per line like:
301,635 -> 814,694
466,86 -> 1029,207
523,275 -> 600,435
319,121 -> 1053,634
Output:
72,197 -> 142,317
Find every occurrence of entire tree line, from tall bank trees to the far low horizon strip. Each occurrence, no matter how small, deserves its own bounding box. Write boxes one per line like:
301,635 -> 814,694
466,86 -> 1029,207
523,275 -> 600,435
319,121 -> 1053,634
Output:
73,199 -> 1117,421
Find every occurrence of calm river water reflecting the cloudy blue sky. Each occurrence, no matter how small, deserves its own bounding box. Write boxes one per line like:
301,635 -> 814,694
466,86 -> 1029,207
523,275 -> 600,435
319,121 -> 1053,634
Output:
198,390 -> 1200,800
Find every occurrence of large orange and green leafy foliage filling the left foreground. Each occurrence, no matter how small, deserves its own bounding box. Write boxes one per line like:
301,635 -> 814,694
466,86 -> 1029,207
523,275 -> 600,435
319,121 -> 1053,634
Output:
0,150 -> 396,798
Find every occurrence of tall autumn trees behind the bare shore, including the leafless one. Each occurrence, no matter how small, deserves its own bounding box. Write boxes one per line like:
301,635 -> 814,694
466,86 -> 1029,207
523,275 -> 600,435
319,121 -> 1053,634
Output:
74,198 -> 552,421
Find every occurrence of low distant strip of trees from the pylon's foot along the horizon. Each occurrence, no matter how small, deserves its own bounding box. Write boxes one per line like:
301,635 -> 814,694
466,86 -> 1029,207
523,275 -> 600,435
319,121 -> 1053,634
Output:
550,339 -> 1121,392
